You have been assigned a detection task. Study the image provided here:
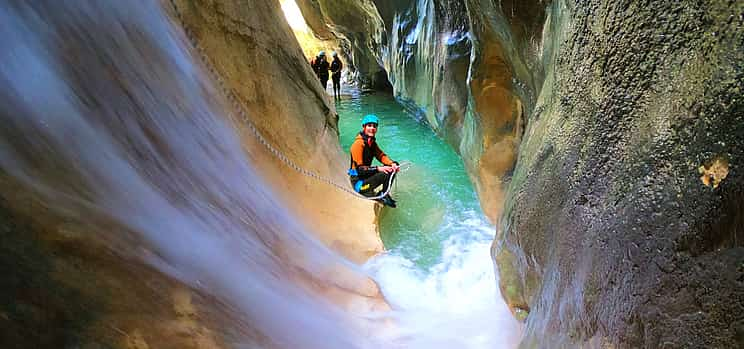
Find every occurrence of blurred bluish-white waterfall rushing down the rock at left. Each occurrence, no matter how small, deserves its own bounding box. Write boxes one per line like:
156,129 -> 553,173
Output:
0,1 -> 374,348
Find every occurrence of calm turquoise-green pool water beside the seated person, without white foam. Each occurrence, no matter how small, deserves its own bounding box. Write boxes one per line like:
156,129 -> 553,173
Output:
336,93 -> 487,269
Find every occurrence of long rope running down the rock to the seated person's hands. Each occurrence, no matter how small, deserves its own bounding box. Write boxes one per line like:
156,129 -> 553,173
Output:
170,0 -> 410,200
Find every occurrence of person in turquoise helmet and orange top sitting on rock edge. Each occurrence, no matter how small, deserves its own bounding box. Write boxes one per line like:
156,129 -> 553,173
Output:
349,114 -> 400,207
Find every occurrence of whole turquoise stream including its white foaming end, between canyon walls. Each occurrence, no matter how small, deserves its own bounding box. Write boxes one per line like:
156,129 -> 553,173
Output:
336,93 -> 520,348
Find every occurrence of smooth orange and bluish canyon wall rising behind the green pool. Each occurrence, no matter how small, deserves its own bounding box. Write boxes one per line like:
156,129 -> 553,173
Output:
297,0 -> 546,220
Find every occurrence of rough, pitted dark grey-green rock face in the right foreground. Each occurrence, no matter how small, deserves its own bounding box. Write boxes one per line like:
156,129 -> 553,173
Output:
494,1 -> 744,348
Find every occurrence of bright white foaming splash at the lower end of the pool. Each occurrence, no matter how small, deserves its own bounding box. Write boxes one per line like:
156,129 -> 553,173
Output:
367,211 -> 522,349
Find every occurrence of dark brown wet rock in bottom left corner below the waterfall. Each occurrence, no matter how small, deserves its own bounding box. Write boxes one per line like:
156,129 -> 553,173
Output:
0,186 -> 229,349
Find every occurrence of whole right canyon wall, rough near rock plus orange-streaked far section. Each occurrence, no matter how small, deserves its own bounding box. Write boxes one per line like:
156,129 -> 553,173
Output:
298,0 -> 744,347
